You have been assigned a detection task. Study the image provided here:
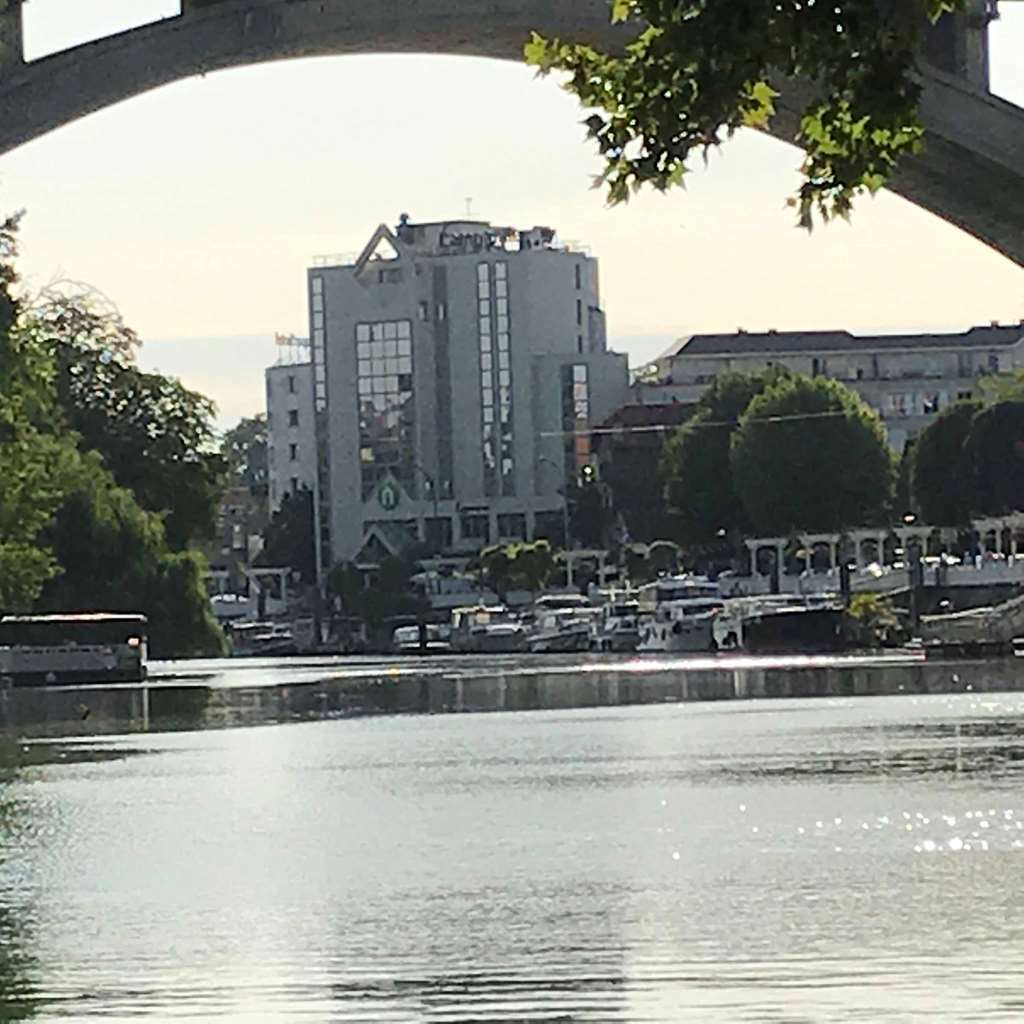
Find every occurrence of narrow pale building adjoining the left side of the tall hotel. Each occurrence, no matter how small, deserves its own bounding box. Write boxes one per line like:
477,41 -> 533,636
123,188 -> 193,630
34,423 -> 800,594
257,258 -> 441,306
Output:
265,349 -> 316,513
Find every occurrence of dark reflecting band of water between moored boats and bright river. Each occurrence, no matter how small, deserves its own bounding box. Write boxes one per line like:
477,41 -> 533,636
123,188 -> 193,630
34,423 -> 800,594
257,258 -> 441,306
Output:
0,653 -> 1024,735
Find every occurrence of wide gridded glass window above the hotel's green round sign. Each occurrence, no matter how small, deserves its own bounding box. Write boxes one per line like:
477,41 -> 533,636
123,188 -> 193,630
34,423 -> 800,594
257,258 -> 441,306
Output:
355,321 -> 417,501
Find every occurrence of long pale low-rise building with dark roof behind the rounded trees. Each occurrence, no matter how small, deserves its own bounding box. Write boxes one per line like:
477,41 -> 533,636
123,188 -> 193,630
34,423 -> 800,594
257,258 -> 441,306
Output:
633,324 -> 1024,452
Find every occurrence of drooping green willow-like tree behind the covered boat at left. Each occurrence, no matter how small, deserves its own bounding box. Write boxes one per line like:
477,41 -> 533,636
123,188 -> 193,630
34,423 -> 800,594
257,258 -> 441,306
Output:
40,453 -> 223,657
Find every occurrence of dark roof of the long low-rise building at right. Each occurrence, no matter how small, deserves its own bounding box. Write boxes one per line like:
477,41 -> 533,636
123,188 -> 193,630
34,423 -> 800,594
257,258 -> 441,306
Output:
663,324 -> 1024,358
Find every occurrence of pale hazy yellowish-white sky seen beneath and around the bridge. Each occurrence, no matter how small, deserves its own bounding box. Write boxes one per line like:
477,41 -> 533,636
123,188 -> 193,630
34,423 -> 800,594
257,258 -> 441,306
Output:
0,0 -> 1024,420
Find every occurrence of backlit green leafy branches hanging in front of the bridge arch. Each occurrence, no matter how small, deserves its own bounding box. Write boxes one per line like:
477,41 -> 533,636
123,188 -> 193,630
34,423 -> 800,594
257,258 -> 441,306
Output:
525,0 -> 967,227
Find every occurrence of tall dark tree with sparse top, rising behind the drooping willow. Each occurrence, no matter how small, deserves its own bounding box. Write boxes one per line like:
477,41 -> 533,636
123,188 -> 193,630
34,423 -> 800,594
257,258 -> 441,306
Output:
31,290 -> 226,549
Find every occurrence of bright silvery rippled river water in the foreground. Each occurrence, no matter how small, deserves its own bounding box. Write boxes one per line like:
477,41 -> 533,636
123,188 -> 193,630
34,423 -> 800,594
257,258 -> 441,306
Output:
6,693 -> 1024,1024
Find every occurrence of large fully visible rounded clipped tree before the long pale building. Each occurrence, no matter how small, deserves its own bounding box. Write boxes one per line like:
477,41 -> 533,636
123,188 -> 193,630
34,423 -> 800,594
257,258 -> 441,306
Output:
730,375 -> 893,536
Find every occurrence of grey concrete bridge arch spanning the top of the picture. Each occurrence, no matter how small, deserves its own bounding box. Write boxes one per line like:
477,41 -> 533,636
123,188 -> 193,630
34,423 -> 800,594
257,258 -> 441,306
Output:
0,0 -> 1024,265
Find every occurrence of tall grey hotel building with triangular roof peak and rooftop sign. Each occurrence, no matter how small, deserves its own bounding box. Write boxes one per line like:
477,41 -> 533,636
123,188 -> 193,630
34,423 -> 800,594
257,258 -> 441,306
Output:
308,216 -> 628,569
